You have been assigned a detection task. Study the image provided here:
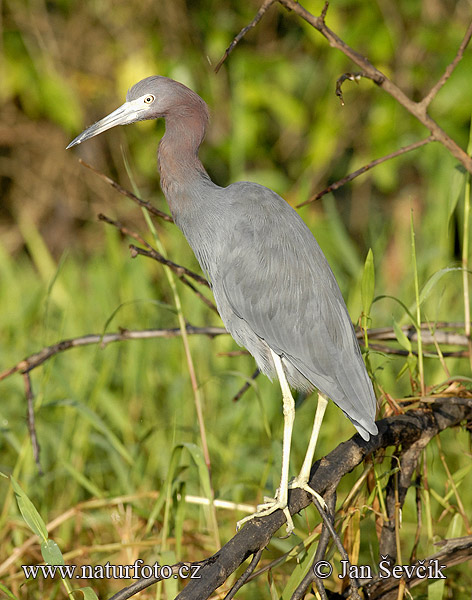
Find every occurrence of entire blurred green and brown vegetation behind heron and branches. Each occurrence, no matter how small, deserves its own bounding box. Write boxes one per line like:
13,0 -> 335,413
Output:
0,0 -> 472,598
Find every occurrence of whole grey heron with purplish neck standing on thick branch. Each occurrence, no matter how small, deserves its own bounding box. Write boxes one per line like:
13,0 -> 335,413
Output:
67,75 -> 378,534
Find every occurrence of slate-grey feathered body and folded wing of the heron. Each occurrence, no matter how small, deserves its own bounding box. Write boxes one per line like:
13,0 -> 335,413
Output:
172,182 -> 377,439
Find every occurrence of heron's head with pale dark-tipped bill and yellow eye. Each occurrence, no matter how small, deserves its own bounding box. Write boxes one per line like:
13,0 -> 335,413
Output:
67,75 -> 207,149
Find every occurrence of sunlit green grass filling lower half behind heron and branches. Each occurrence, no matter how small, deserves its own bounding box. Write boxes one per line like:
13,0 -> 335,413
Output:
0,137 -> 472,599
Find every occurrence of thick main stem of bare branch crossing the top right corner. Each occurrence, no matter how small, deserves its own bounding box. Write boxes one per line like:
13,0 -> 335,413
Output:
277,0 -> 472,173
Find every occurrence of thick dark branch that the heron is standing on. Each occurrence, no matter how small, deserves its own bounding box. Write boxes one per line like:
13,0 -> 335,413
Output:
107,396 -> 472,600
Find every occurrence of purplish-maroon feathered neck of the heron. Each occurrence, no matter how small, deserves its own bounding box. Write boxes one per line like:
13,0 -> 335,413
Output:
158,102 -> 211,214
